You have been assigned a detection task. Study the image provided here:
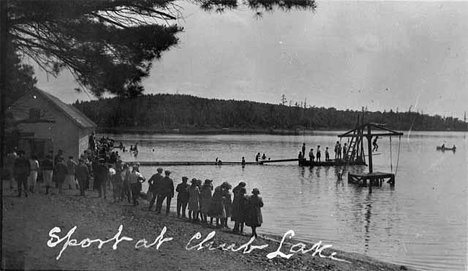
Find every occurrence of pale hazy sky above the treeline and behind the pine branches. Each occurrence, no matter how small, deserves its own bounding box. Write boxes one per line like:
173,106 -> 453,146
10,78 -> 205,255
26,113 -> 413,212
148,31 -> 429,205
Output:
36,1 -> 468,119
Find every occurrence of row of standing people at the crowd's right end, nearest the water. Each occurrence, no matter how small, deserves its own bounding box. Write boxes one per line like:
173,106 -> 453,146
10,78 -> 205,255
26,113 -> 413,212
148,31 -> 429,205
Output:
143,168 -> 263,237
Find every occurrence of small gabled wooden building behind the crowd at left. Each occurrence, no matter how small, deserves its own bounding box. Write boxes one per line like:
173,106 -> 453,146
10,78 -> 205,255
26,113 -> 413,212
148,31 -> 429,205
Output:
7,89 -> 97,159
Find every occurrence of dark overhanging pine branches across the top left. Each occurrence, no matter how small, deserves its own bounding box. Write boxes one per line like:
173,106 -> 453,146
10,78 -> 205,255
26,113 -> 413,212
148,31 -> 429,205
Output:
2,0 -> 315,97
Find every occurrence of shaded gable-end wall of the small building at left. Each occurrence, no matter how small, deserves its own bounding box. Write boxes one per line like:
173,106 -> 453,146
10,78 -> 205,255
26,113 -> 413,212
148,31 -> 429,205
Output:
10,94 -> 85,158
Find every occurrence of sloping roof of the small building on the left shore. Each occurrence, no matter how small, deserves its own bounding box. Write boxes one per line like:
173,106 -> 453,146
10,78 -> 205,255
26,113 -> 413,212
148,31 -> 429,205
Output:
36,88 -> 97,128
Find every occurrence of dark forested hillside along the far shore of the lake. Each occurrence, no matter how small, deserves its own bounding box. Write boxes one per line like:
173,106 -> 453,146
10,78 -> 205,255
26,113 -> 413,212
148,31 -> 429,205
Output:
74,94 -> 468,131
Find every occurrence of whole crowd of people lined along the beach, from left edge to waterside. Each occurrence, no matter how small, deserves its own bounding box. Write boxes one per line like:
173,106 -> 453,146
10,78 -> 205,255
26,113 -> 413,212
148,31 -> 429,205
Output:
7,138 -> 263,237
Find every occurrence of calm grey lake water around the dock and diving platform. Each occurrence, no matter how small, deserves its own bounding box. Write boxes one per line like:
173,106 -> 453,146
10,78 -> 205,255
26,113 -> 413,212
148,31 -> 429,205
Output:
100,132 -> 468,270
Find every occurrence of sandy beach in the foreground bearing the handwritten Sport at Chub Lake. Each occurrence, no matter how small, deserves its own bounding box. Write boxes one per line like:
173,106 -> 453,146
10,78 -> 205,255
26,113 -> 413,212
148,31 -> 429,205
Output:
2,182 -> 410,271
